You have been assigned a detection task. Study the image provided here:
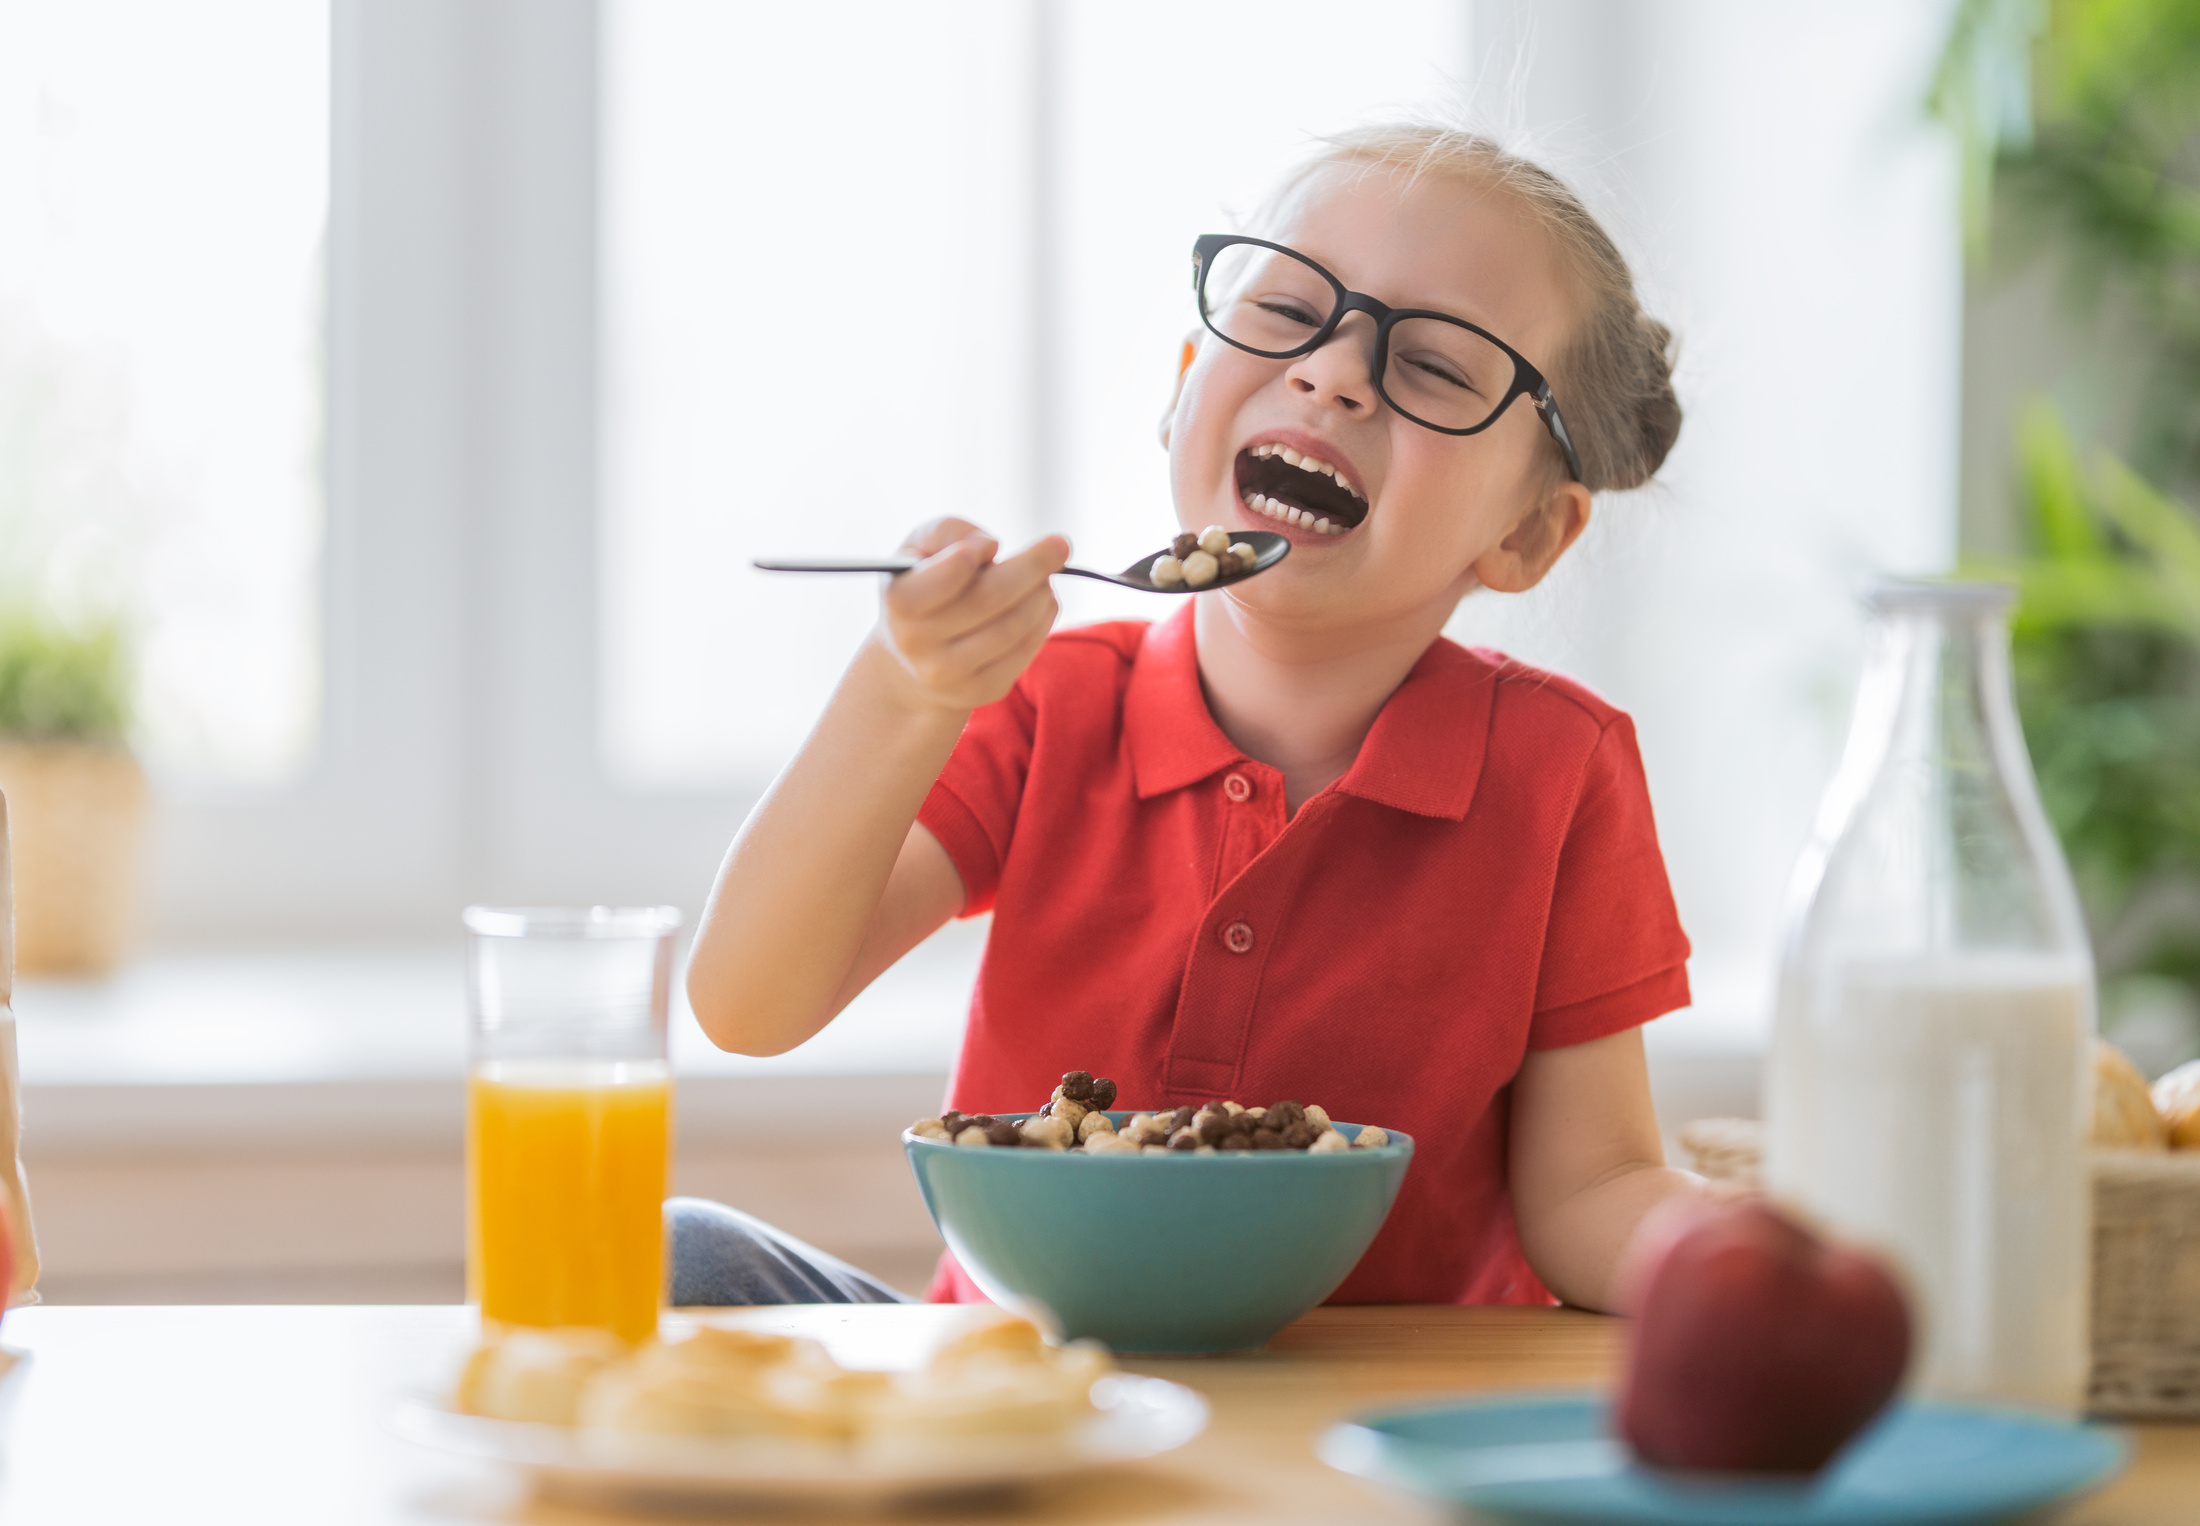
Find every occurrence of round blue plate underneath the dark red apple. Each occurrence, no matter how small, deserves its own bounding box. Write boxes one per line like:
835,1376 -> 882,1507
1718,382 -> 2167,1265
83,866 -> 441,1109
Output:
1322,1394 -> 2130,1526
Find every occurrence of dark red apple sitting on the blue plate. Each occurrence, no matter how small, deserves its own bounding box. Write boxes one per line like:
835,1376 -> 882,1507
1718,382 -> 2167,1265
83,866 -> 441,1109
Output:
1619,1201 -> 1910,1473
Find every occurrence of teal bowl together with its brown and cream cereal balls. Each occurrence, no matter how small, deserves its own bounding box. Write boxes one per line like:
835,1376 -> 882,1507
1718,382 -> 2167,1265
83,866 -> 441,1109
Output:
902,1071 -> 1412,1354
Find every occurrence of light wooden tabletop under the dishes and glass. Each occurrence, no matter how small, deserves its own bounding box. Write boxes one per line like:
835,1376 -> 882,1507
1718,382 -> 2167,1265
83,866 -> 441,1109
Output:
0,1306 -> 2200,1526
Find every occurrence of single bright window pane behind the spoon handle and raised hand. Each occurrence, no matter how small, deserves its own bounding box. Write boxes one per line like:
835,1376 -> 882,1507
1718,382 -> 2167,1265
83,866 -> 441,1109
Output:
603,0 -> 1032,785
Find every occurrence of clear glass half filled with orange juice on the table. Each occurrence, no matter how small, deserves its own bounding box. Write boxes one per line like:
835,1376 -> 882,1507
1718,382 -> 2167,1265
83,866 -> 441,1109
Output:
464,906 -> 680,1341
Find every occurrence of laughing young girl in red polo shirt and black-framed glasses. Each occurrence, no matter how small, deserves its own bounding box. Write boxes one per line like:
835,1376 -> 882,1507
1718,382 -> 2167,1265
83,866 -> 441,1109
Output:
673,125 -> 1694,1308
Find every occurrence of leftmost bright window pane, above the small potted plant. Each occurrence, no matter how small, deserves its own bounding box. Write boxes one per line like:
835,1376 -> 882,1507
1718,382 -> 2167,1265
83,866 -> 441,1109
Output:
0,0 -> 330,783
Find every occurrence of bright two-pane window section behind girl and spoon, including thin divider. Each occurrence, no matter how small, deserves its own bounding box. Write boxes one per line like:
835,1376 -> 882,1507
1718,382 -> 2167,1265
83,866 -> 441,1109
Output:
603,0 -> 1470,787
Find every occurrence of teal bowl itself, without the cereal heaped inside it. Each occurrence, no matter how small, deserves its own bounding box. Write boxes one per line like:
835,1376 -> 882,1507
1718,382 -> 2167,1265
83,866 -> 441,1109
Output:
902,1113 -> 1412,1354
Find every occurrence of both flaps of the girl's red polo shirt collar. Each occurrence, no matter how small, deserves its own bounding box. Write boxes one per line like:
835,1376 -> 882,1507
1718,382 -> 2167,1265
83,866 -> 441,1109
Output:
1124,600 -> 1498,820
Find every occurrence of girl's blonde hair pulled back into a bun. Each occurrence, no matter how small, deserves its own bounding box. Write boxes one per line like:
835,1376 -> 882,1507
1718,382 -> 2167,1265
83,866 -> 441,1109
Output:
1261,119 -> 1681,493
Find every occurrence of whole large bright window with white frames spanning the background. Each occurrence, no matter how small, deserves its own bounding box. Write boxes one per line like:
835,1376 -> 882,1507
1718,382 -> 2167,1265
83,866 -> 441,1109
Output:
34,0 -> 1958,1002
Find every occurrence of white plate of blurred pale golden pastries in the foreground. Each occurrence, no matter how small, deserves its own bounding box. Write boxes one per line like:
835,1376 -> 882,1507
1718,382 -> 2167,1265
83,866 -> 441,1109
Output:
392,1311 -> 1208,1508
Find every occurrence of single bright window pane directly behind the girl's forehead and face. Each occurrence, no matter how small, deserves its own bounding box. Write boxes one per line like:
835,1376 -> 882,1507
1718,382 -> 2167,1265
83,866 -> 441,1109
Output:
1047,0 -> 1474,622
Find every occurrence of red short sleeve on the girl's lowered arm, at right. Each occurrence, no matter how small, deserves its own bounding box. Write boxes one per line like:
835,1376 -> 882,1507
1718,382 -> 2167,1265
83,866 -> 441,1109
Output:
1529,715 -> 1690,1049
